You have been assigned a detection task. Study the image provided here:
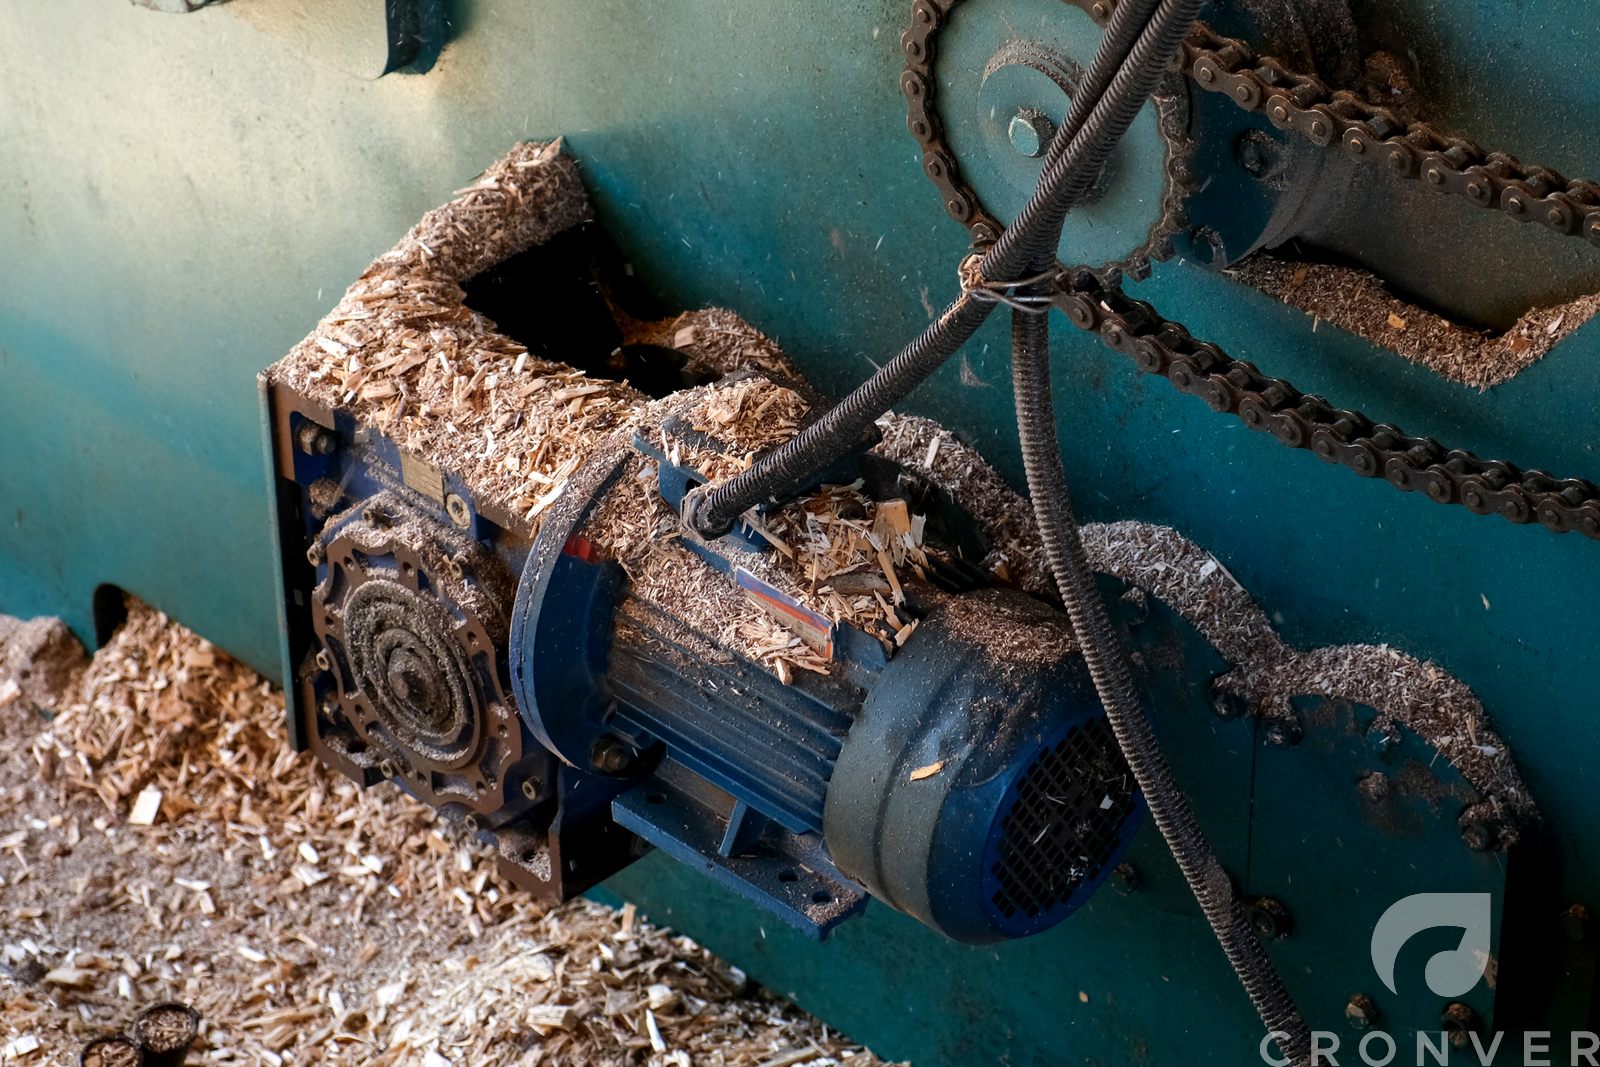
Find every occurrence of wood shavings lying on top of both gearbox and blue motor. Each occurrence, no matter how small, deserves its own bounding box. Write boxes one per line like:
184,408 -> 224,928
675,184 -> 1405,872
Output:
267,142 -> 925,677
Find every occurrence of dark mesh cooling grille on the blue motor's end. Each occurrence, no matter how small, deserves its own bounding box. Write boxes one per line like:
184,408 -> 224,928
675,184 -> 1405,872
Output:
989,718 -> 1138,923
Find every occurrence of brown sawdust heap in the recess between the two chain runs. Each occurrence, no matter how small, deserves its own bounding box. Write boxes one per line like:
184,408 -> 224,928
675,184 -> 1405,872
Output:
1227,253 -> 1600,390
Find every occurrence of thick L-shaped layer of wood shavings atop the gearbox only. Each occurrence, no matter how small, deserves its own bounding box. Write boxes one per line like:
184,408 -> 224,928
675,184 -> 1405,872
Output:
267,141 -> 645,523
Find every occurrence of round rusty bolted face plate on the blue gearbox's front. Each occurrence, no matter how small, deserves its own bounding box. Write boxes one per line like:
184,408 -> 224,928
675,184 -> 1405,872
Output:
314,518 -> 522,814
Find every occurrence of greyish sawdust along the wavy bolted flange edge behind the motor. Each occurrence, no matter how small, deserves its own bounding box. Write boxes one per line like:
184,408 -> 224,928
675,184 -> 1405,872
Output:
880,416 -> 1538,835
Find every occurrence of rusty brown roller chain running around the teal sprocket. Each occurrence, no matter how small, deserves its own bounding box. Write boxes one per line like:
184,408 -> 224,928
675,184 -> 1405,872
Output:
901,0 -> 1600,539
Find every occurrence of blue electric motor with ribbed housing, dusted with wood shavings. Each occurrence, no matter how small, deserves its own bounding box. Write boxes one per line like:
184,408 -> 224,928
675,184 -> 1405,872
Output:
510,391 -> 1142,942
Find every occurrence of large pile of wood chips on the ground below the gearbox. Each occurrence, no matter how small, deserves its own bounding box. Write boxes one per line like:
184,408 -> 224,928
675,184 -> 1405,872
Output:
0,605 -> 902,1067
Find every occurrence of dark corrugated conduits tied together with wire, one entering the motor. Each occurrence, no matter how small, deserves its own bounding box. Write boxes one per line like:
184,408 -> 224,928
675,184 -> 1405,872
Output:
685,0 -> 1310,1065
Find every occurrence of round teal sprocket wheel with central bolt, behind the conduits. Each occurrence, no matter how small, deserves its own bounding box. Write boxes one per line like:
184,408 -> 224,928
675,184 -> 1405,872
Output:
907,0 -> 1187,275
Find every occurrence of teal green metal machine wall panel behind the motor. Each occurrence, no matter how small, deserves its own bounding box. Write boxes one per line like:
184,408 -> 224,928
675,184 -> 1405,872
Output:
0,0 -> 1600,1065
